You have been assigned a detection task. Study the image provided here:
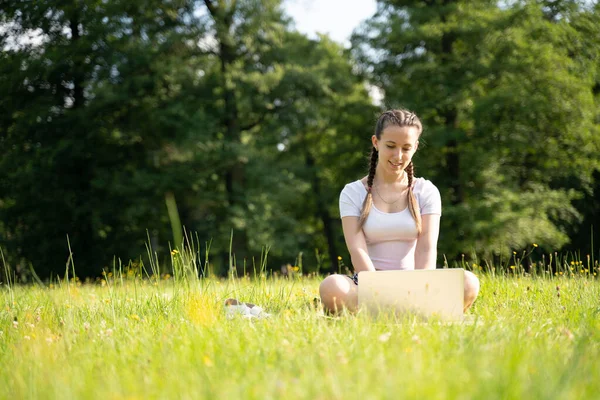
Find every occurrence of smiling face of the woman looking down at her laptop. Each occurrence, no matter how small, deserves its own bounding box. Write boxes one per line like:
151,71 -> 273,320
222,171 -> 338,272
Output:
371,125 -> 419,175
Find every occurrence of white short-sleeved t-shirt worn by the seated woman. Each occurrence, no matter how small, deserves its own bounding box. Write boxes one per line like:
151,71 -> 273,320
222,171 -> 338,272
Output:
340,178 -> 442,270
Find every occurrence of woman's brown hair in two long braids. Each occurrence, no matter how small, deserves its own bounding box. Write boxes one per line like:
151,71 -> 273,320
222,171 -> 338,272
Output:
358,109 -> 423,234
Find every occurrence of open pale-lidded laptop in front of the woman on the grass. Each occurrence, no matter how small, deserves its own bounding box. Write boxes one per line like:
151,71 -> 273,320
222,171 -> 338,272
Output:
358,268 -> 465,321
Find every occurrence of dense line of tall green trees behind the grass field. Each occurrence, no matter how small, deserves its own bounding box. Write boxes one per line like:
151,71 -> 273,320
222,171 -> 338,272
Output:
0,0 -> 600,277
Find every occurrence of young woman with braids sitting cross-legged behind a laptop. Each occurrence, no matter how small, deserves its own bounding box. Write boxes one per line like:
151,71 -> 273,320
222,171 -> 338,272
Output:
319,110 -> 479,312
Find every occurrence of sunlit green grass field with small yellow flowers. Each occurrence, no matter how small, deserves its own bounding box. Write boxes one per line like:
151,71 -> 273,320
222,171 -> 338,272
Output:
0,266 -> 600,400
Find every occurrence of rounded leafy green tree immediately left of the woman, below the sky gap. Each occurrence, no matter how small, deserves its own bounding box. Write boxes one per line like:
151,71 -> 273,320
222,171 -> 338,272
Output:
243,33 -> 376,271
